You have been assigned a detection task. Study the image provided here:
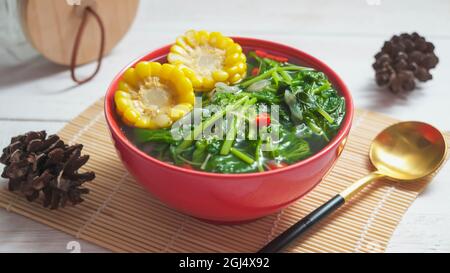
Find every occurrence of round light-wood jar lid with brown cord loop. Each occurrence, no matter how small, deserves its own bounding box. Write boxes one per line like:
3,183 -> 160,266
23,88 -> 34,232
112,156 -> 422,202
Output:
20,0 -> 139,65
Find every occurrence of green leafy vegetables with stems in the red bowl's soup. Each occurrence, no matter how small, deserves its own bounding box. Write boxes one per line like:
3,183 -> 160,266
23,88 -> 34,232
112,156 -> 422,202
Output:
125,52 -> 345,173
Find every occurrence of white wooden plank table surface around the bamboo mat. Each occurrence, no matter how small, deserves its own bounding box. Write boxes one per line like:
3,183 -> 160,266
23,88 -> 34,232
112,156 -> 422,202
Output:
0,0 -> 450,252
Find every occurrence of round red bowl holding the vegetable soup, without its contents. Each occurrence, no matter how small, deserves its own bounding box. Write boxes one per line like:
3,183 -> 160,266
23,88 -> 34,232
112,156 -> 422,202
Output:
104,37 -> 353,222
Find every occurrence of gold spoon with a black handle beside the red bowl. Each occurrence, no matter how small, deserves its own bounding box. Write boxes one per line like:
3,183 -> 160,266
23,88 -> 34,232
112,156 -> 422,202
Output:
258,121 -> 447,253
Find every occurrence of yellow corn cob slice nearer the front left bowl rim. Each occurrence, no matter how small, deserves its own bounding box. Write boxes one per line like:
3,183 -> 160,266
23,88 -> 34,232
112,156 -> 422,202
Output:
114,62 -> 195,129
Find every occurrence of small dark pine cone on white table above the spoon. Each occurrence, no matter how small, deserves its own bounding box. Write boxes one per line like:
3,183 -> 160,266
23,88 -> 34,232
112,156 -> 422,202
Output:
373,32 -> 439,93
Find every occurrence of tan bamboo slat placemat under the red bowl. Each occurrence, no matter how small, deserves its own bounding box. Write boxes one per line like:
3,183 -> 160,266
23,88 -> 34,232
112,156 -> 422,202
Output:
0,101 -> 450,252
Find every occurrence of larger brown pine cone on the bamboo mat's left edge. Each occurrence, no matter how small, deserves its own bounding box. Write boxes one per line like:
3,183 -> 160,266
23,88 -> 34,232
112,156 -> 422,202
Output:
0,131 -> 95,209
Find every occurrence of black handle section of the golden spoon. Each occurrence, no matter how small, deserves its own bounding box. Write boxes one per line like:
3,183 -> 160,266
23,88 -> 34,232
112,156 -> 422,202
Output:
258,194 -> 345,253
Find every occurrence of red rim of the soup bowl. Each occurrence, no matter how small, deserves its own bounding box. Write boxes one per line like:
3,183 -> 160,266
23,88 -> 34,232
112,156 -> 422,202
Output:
104,36 -> 354,179
